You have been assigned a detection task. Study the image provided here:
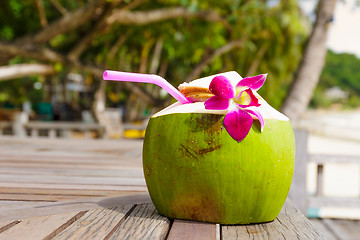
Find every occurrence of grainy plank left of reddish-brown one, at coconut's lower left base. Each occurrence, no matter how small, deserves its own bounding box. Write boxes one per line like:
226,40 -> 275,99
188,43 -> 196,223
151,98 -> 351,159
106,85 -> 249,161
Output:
108,204 -> 170,240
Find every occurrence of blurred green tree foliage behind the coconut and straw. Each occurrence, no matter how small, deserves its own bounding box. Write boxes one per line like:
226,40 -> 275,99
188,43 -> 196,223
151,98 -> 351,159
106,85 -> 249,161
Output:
0,0 -> 308,112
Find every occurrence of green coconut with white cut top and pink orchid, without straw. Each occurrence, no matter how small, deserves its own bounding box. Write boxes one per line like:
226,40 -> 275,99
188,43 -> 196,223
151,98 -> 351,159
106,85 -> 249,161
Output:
102,72 -> 295,224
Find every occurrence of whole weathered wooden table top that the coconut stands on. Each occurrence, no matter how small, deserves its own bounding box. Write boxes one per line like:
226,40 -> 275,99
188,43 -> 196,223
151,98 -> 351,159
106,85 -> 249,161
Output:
0,138 -> 325,240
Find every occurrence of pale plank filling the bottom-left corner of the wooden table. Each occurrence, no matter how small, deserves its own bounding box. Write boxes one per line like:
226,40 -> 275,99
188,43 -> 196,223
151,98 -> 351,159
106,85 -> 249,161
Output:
0,212 -> 85,240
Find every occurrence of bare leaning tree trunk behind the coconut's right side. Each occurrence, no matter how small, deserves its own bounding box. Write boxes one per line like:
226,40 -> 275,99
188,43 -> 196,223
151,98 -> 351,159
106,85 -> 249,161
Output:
281,0 -> 337,125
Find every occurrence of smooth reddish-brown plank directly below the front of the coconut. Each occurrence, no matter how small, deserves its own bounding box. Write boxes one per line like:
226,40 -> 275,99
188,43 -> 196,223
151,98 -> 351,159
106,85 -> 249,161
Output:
167,219 -> 216,240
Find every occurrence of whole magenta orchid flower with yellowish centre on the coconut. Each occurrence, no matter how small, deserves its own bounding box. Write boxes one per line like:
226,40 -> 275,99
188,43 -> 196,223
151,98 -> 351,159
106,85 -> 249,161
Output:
204,74 -> 267,142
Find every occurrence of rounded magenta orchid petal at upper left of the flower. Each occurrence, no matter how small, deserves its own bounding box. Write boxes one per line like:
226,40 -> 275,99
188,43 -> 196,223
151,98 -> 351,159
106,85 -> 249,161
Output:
209,75 -> 235,99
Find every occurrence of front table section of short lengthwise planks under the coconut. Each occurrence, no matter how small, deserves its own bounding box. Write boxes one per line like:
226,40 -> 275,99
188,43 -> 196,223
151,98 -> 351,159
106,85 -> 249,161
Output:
0,198 -> 325,240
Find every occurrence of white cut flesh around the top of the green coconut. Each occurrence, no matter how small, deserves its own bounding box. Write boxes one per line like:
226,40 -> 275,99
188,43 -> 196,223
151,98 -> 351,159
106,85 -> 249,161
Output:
152,71 -> 289,121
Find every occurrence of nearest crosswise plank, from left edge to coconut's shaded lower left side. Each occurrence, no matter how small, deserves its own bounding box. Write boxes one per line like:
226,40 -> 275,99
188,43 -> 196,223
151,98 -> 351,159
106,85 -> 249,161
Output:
0,194 -> 151,221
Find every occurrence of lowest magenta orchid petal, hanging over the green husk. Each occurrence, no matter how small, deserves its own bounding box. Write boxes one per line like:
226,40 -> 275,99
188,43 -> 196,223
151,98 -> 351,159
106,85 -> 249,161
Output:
224,108 -> 253,142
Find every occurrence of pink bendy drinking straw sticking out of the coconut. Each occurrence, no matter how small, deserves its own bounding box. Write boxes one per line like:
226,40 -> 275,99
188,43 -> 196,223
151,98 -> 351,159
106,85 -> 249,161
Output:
103,70 -> 191,104
